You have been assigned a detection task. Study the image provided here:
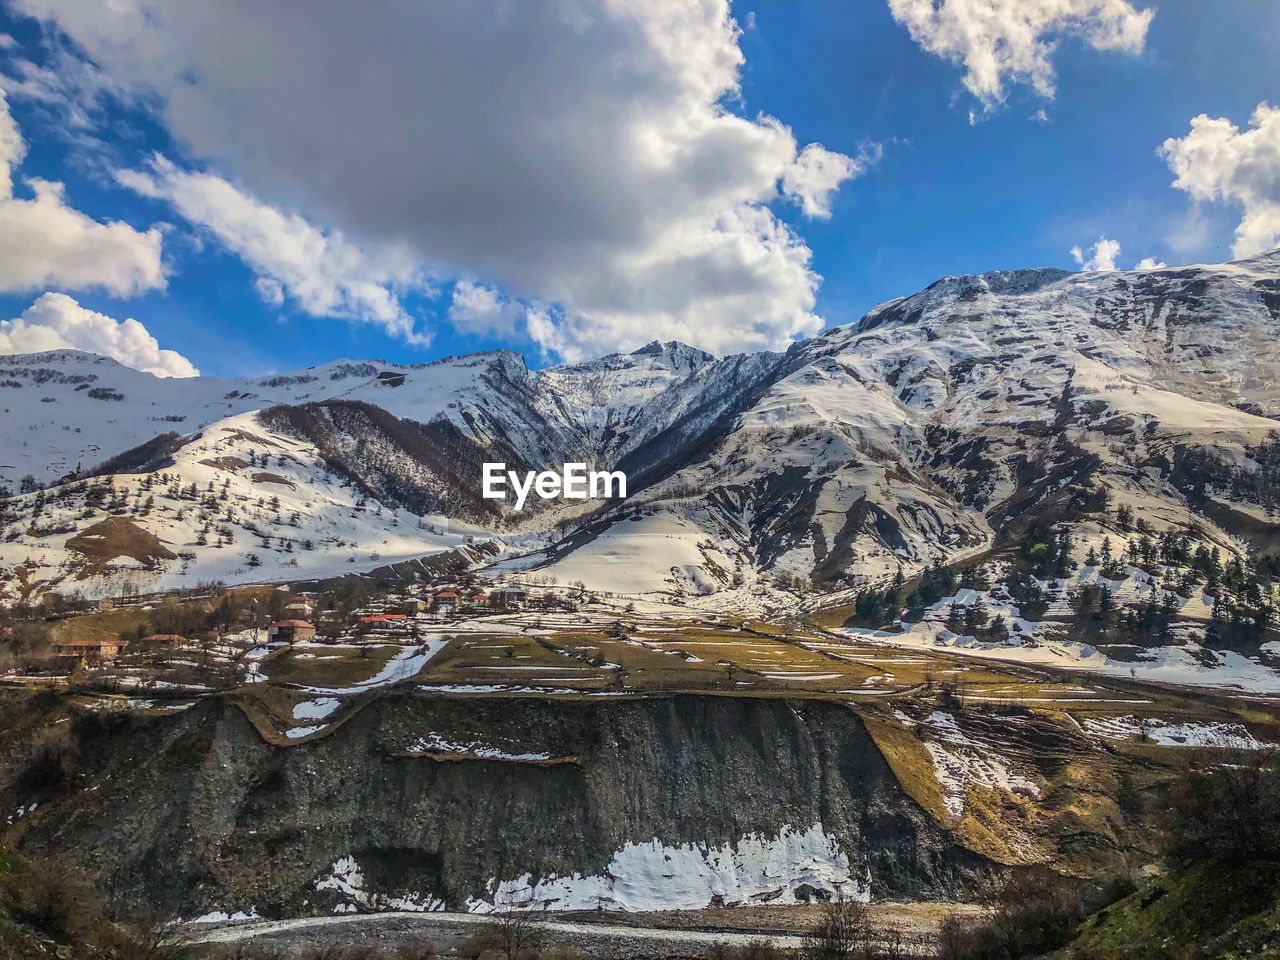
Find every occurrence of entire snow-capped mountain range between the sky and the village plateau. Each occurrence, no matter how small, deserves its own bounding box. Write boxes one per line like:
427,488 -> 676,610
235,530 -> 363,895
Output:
0,252 -> 1280,640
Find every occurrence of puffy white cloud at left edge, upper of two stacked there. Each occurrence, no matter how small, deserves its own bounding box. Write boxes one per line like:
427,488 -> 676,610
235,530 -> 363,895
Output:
0,91 -> 165,297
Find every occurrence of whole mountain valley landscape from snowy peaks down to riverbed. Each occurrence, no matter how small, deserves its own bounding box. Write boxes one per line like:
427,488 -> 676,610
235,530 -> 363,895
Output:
0,253 -> 1280,957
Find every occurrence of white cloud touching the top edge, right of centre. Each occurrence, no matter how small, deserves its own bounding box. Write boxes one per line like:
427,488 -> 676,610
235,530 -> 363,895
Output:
888,0 -> 1155,110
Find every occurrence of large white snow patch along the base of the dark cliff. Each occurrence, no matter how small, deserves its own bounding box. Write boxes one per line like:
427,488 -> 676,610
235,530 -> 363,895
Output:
467,823 -> 870,913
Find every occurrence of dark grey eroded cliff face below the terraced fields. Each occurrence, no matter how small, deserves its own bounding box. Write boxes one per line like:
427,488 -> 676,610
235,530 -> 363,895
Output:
23,694 -> 996,918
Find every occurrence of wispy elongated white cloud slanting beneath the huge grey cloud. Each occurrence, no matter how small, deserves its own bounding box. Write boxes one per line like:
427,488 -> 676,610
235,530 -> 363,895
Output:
116,156 -> 430,344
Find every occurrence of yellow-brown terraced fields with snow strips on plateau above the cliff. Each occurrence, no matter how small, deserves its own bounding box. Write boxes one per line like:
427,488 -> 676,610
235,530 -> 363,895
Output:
35,611 -> 1280,873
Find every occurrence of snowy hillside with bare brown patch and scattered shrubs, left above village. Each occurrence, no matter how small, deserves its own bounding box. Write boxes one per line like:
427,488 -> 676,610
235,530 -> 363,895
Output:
0,413 -> 486,595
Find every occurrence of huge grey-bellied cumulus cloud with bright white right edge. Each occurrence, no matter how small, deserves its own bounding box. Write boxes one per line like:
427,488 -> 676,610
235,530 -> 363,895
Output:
17,0 -> 867,351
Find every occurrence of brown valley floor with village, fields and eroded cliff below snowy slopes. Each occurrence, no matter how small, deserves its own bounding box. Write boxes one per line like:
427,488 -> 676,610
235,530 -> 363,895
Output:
0,572 -> 1280,957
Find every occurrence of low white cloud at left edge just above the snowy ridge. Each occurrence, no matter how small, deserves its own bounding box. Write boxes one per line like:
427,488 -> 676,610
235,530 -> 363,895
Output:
0,293 -> 200,376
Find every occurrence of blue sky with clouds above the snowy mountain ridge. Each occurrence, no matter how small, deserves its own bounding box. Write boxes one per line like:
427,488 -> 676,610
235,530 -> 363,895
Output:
0,0 -> 1280,376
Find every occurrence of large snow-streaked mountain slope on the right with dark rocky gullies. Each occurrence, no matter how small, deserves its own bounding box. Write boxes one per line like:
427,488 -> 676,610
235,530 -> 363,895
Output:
522,253 -> 1280,601
